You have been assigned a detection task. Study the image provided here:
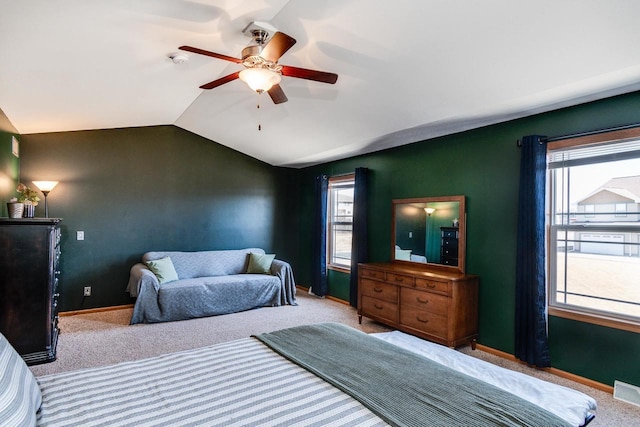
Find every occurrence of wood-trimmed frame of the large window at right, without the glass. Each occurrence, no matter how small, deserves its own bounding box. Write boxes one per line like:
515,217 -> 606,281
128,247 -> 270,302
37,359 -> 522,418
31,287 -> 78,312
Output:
546,127 -> 640,333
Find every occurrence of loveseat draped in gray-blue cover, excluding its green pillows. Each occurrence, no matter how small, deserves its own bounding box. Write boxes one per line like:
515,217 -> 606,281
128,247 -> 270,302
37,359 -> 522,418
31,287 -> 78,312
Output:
127,248 -> 297,324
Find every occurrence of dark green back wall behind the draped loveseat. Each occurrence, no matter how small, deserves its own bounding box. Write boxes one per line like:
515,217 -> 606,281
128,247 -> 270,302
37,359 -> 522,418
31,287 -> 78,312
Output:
21,126 -> 297,311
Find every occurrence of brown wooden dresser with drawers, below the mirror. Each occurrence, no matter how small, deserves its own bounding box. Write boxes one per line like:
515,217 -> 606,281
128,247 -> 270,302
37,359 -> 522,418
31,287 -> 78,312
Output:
358,263 -> 478,347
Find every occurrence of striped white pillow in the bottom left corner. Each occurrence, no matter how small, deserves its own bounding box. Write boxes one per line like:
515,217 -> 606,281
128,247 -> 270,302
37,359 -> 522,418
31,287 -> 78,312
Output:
0,334 -> 42,426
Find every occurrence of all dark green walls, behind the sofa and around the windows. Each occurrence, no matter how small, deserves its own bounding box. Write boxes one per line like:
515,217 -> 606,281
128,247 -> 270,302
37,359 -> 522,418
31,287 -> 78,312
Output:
6,93 -> 640,385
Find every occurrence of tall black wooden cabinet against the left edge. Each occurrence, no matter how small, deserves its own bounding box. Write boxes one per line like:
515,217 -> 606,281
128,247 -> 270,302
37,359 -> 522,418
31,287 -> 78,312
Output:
0,218 -> 61,364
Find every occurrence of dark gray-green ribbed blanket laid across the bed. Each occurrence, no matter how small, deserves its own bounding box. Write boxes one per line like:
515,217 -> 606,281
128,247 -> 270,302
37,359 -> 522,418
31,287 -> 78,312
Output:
257,323 -> 571,427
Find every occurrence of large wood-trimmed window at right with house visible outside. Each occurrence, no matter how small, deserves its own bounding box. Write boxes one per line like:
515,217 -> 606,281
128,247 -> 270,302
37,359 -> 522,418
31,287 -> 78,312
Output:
547,129 -> 640,330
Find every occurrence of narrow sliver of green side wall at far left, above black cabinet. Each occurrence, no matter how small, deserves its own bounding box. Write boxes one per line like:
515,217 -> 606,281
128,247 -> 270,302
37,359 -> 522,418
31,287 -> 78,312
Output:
0,106 -> 20,217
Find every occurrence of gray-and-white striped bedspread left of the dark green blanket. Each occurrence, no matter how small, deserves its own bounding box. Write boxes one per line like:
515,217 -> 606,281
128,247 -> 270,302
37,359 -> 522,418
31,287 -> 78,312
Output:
37,338 -> 386,426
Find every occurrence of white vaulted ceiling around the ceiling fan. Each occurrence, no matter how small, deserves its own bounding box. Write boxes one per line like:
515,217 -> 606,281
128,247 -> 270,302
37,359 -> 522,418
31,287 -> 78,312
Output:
0,0 -> 640,167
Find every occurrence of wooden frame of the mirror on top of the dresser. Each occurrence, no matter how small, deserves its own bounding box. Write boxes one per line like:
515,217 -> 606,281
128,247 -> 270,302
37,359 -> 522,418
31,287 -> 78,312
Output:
391,195 -> 467,274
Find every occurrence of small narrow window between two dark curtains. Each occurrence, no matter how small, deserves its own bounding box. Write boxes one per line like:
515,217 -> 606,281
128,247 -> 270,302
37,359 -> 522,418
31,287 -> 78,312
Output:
327,174 -> 355,270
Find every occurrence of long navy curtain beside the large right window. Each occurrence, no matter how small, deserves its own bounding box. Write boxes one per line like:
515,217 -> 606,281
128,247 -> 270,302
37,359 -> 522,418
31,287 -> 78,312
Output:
515,135 -> 551,368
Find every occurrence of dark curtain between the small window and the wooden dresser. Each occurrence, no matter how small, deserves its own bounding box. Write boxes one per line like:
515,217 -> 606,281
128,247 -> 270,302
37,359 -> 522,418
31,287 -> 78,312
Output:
349,168 -> 369,307
